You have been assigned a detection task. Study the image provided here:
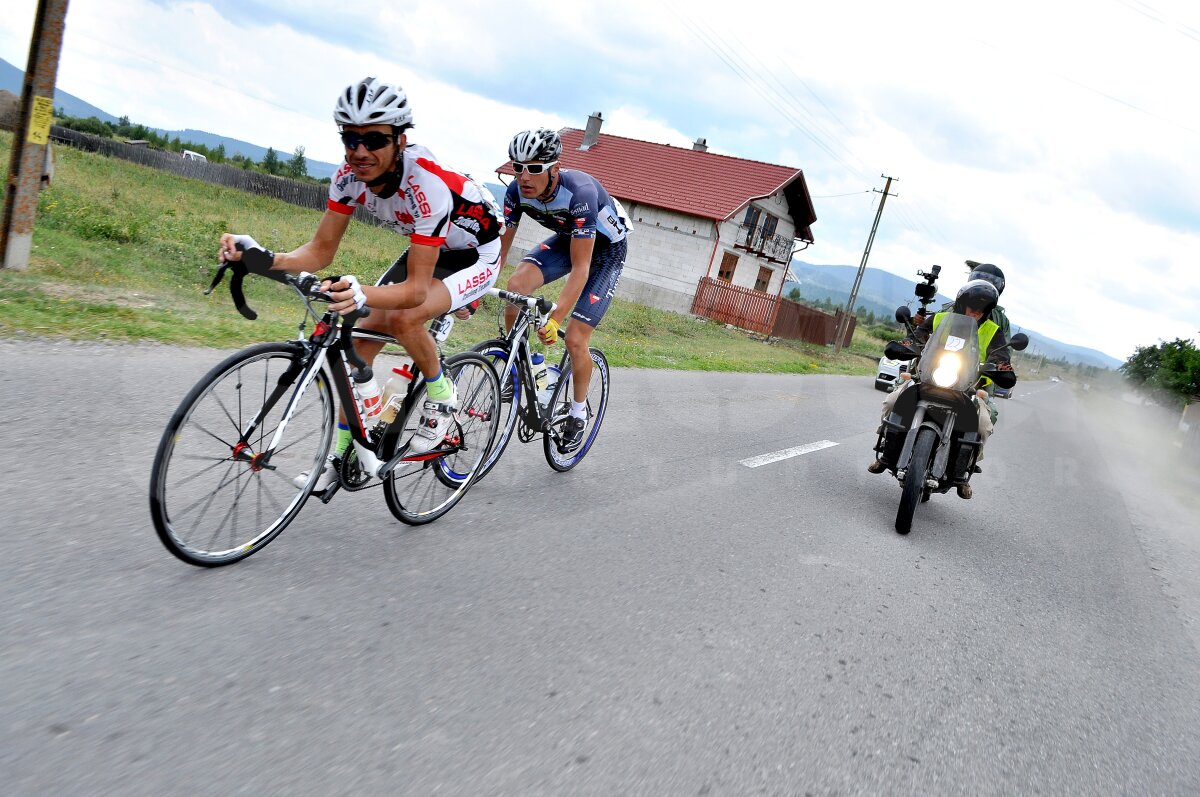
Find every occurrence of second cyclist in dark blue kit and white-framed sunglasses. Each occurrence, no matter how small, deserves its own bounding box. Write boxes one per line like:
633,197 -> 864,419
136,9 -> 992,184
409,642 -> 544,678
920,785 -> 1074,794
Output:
500,127 -> 629,445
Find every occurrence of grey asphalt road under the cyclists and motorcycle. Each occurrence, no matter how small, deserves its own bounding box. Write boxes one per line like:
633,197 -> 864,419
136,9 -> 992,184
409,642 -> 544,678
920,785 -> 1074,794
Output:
0,342 -> 1200,795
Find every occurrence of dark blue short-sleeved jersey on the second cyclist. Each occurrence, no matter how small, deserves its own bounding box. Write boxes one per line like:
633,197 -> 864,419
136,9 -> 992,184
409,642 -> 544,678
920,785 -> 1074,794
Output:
504,169 -> 629,244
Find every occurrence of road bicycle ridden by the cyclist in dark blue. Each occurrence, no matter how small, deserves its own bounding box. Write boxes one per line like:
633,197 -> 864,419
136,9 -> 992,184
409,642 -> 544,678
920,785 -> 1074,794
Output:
472,288 -> 610,480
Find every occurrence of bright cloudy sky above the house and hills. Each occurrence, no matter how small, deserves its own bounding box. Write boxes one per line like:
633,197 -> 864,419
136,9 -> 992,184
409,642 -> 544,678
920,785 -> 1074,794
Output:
0,0 -> 1200,359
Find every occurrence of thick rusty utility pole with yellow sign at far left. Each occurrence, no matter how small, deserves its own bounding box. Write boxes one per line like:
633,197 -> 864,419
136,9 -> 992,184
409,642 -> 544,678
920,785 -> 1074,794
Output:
0,0 -> 67,269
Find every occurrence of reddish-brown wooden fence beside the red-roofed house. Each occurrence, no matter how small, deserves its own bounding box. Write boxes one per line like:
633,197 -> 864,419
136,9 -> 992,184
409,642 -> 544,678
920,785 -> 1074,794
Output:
691,277 -> 856,346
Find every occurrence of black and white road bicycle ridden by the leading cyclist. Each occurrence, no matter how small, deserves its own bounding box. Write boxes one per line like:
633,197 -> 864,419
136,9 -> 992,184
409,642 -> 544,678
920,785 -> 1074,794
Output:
150,262 -> 502,567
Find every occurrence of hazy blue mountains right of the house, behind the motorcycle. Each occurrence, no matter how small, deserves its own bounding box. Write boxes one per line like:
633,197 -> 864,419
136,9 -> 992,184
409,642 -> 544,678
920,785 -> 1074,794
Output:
784,259 -> 1122,368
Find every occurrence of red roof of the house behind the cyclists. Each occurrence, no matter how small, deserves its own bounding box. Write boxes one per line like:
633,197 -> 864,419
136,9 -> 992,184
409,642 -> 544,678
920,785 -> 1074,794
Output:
496,127 -> 816,240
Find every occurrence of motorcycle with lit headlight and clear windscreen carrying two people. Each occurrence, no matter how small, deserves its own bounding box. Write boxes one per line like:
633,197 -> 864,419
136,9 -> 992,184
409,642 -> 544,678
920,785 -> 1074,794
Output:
875,306 -> 1030,534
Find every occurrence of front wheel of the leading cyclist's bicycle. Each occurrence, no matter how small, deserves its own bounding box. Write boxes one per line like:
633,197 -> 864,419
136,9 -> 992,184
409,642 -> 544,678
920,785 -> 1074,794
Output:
150,343 -> 334,567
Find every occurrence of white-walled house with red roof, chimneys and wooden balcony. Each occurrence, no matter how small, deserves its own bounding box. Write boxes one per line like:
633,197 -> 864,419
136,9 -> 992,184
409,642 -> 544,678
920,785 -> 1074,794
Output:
497,112 -> 817,312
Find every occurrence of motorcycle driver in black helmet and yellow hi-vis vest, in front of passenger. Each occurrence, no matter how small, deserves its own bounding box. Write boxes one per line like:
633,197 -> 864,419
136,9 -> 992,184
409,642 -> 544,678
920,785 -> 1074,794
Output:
866,280 -> 1016,498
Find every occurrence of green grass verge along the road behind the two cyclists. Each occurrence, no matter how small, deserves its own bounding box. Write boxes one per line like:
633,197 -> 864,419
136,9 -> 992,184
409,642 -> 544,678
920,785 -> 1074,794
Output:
0,131 -> 883,374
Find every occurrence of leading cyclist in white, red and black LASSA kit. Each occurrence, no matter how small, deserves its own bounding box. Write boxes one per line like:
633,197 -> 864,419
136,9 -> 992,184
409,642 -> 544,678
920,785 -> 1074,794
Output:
220,78 -> 504,492
